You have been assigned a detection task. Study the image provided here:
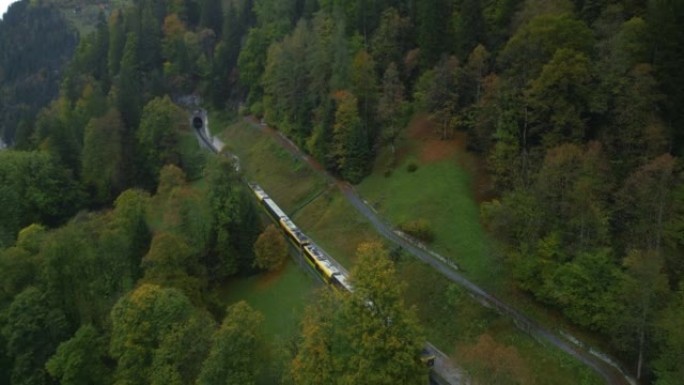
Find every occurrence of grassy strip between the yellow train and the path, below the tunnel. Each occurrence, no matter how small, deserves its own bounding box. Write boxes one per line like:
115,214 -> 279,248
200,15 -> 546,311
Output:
221,118 -> 378,269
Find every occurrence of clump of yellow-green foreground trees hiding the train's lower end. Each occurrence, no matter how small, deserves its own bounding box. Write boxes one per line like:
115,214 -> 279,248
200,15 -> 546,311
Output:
292,241 -> 426,385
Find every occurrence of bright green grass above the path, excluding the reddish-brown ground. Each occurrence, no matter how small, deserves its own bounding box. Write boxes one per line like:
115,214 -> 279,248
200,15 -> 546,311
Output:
358,157 -> 501,287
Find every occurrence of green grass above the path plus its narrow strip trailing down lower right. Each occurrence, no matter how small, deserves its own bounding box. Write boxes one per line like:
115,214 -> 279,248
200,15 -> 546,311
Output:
357,129 -> 620,351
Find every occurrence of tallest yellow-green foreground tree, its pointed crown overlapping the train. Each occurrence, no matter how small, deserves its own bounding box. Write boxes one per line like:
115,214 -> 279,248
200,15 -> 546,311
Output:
340,242 -> 427,385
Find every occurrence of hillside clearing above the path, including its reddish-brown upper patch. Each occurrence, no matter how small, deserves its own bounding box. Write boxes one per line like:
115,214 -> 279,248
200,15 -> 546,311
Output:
358,116 -> 502,288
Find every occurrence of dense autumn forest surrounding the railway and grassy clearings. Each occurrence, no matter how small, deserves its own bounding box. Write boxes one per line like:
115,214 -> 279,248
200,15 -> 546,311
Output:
0,0 -> 684,385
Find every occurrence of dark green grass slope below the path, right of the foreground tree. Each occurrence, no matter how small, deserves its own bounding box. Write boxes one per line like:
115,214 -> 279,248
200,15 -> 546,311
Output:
398,259 -> 602,385
